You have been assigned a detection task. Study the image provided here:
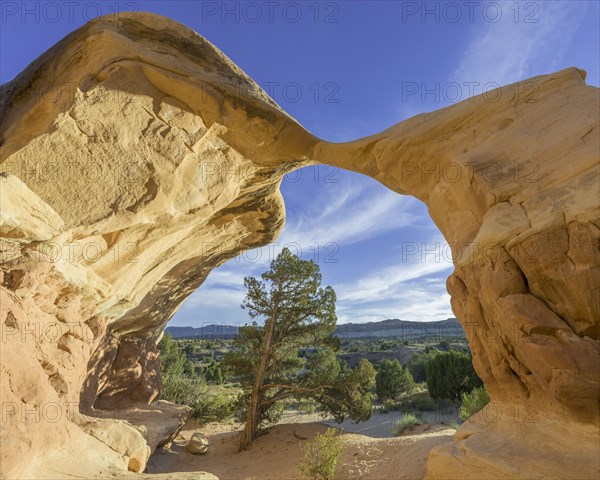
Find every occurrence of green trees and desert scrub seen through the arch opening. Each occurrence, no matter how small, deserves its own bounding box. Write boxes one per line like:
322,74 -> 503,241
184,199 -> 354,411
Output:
159,249 -> 489,436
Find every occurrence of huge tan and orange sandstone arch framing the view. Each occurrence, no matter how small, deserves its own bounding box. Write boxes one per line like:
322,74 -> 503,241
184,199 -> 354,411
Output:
0,14 -> 600,479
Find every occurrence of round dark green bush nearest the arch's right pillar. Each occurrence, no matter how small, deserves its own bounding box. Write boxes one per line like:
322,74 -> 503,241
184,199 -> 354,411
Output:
426,350 -> 483,400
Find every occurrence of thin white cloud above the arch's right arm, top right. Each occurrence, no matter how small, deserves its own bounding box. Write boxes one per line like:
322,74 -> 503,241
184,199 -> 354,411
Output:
398,0 -> 589,124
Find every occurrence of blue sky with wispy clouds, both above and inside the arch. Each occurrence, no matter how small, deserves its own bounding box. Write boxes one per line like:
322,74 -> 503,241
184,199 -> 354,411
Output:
0,0 -> 600,326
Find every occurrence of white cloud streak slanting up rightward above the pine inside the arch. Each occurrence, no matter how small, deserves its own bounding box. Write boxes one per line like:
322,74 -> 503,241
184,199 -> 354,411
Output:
179,173 -> 419,318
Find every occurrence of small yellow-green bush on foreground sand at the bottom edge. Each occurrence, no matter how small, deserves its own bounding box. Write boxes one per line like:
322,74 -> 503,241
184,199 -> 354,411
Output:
298,428 -> 344,480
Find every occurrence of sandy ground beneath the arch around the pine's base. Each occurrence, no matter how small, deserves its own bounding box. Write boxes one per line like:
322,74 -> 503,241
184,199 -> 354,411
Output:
147,412 -> 455,480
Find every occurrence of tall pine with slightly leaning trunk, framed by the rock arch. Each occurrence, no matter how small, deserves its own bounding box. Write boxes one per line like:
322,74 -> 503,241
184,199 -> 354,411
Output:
223,248 -> 375,450
